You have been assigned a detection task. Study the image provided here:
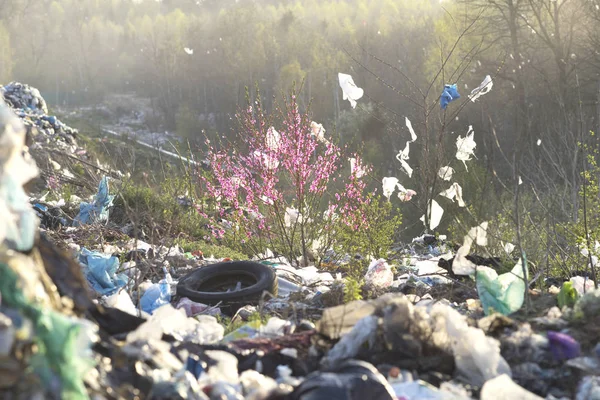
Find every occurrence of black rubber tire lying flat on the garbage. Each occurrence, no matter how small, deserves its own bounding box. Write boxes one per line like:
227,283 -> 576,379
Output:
177,261 -> 278,306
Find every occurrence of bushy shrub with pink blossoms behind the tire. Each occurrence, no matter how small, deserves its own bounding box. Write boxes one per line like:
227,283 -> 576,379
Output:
198,91 -> 371,263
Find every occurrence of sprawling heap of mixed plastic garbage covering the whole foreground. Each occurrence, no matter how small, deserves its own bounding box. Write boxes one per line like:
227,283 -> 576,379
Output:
0,83 -> 600,400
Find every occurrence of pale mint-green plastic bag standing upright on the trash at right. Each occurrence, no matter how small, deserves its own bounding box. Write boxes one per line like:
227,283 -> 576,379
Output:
476,259 -> 526,315
